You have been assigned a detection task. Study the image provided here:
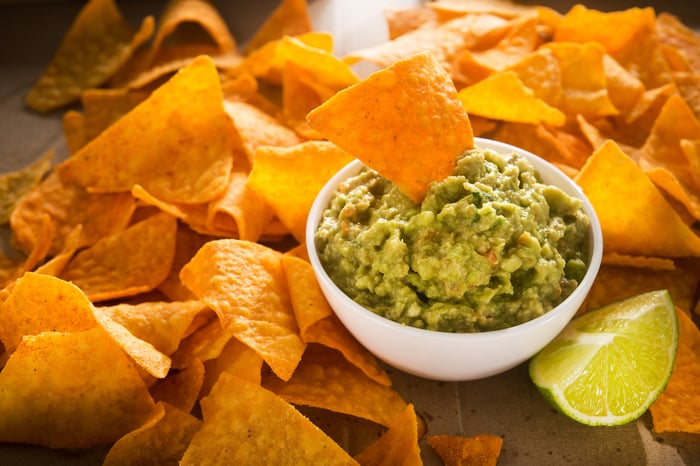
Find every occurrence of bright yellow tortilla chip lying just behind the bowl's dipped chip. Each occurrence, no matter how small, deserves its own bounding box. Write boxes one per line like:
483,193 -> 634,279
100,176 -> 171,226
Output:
459,70 -> 566,126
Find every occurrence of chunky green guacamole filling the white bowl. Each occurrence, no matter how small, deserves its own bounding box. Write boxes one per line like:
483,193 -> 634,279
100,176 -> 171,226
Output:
315,148 -> 589,332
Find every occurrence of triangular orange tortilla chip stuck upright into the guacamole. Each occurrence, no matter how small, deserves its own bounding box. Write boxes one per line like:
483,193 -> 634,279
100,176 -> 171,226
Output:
307,52 -> 474,203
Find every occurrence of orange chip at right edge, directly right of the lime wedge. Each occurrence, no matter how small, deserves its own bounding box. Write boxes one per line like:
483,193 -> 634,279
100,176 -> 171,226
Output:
649,308 -> 700,434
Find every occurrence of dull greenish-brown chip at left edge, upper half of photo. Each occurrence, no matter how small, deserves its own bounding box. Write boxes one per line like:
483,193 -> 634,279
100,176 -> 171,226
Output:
0,150 -> 54,225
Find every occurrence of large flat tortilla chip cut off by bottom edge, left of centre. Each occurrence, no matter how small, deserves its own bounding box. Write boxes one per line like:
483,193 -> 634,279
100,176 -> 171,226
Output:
180,373 -> 357,466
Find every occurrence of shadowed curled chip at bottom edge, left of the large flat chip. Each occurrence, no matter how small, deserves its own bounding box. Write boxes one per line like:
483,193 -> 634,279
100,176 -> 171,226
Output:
102,402 -> 202,466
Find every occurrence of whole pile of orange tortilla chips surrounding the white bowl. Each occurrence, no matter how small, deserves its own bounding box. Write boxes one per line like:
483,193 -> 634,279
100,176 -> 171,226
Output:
0,0 -> 700,465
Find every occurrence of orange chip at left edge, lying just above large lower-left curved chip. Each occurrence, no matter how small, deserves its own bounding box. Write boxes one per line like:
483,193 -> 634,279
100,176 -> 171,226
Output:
0,272 -> 97,353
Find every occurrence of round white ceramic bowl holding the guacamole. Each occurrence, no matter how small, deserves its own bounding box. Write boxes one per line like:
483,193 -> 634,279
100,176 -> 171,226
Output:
306,138 -> 603,381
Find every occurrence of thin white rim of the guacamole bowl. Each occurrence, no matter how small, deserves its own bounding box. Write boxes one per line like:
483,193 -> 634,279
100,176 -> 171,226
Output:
305,137 -> 603,340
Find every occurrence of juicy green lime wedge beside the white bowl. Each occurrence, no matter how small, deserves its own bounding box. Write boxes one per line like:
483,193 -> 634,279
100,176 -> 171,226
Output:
529,290 -> 678,426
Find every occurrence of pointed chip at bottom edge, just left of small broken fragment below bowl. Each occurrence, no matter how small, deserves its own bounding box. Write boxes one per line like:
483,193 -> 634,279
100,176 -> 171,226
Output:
354,404 -> 423,466
